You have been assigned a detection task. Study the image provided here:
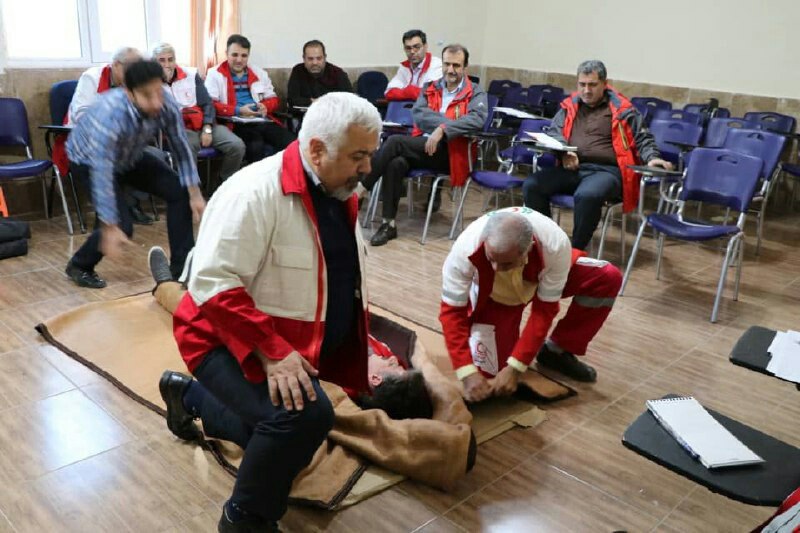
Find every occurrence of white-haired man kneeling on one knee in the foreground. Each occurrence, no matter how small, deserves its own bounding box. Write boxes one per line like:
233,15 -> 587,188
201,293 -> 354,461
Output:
160,93 -> 382,531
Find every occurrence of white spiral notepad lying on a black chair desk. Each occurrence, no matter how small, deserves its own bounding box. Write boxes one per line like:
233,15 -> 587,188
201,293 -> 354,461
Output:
646,397 -> 764,468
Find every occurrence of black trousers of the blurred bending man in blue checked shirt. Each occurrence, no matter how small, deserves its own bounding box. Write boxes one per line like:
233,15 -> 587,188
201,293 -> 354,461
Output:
70,149 -> 194,279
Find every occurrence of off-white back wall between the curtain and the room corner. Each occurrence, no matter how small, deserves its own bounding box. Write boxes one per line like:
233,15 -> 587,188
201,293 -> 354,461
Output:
239,0 -> 485,67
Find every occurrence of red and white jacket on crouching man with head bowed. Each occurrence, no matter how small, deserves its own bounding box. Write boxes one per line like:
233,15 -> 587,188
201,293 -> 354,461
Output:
439,207 -> 574,379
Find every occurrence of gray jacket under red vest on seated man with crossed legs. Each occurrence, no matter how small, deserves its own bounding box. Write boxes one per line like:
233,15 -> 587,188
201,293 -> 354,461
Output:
411,78 -> 488,139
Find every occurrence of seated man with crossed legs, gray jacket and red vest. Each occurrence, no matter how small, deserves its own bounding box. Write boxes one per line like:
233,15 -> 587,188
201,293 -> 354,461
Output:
363,44 -> 488,246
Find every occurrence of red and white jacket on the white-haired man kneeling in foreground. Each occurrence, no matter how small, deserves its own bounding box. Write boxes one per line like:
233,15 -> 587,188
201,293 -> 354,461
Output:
173,141 -> 368,393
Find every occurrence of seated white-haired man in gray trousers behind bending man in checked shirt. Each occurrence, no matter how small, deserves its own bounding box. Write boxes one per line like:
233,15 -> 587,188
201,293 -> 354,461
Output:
152,43 -> 244,181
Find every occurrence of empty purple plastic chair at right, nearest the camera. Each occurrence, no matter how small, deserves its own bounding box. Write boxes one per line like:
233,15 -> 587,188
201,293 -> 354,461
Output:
619,148 -> 764,322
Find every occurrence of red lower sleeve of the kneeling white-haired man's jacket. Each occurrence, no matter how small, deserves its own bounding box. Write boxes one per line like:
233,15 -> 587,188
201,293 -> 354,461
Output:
200,287 -> 294,365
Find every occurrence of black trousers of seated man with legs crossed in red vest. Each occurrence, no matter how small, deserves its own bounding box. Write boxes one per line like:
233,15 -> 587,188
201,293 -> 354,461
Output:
363,135 -> 450,220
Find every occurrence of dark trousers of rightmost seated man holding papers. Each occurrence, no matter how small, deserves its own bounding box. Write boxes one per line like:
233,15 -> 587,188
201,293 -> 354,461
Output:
522,163 -> 622,250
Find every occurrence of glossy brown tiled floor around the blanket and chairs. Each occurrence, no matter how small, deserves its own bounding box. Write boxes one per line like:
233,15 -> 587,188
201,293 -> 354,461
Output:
0,185 -> 800,533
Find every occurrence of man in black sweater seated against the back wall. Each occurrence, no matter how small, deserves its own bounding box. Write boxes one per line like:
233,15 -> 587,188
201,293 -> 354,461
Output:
288,40 -> 353,107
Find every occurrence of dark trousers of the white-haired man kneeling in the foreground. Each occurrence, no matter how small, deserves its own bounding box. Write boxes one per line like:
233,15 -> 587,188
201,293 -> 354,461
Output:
192,347 -> 333,521
